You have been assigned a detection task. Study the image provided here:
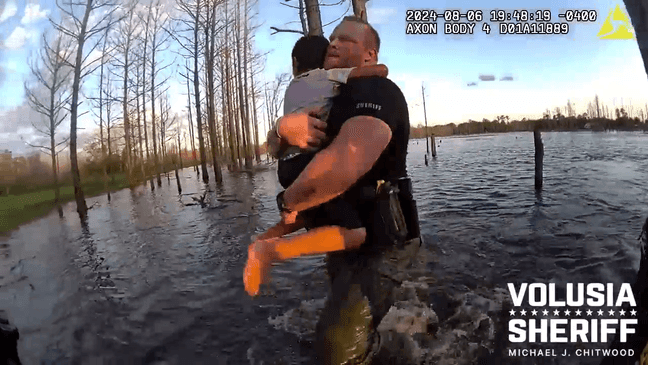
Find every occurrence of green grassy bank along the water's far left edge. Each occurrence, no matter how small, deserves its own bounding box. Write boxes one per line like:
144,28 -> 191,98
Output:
0,174 -> 129,233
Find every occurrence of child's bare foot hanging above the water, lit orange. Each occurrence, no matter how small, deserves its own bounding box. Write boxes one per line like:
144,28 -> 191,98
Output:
243,238 -> 276,296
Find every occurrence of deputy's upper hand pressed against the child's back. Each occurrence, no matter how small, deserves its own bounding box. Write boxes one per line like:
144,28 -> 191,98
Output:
277,107 -> 326,151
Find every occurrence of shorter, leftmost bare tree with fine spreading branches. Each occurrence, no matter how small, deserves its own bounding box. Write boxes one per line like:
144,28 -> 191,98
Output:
25,33 -> 73,217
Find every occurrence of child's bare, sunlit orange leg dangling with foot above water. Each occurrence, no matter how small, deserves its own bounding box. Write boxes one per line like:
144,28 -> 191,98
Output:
243,226 -> 367,295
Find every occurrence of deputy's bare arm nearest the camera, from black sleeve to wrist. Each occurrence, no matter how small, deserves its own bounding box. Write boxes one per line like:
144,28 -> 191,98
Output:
284,115 -> 392,211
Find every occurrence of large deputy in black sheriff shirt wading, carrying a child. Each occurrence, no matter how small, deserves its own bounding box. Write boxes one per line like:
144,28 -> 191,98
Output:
268,17 -> 421,365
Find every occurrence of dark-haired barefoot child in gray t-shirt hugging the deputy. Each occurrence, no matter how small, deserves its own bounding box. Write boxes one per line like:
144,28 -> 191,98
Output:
243,36 -> 387,295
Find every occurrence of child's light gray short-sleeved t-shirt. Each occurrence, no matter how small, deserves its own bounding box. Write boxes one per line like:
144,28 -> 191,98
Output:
280,68 -> 353,159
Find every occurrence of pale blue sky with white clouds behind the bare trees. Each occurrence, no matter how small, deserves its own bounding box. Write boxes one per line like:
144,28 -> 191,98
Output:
0,0 -> 648,152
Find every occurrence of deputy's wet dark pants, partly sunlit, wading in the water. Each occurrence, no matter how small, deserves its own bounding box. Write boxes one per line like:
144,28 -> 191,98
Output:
315,235 -> 421,365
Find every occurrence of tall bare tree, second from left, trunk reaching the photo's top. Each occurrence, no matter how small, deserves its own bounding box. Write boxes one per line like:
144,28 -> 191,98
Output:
50,0 -> 117,221
